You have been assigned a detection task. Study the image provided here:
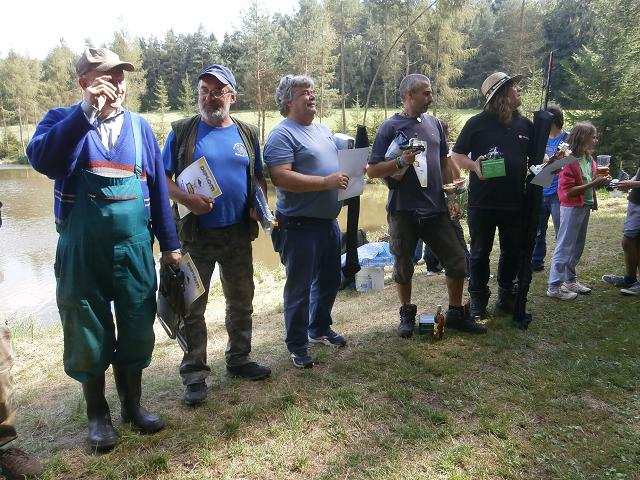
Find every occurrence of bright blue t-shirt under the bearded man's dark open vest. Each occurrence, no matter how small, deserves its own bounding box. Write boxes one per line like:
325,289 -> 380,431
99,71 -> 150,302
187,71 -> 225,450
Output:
162,121 -> 262,228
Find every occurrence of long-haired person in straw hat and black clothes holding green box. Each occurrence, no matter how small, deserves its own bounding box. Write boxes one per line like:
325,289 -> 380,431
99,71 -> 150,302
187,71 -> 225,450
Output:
453,72 -> 534,326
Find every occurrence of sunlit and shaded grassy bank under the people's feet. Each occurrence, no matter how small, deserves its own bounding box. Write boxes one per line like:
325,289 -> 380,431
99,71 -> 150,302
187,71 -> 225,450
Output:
8,193 -> 640,480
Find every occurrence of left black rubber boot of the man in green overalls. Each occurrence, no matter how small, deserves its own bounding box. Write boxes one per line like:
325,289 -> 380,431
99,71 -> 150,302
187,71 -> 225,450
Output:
82,374 -> 118,451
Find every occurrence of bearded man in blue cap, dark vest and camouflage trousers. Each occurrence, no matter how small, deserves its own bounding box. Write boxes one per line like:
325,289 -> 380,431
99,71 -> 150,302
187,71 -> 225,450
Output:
162,65 -> 271,405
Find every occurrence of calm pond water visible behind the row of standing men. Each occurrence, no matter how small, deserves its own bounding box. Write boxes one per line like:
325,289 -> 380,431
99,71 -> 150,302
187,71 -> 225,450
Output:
0,166 -> 386,324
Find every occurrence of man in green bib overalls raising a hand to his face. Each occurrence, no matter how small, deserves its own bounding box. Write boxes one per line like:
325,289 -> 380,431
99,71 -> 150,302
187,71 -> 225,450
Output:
27,48 -> 180,450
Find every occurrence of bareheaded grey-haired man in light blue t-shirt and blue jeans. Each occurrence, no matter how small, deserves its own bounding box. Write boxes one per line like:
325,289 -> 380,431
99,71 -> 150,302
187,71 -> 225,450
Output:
264,75 -> 349,368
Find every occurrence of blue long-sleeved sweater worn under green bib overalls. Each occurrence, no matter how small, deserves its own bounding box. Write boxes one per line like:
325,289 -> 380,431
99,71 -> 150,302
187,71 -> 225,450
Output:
27,104 -> 180,252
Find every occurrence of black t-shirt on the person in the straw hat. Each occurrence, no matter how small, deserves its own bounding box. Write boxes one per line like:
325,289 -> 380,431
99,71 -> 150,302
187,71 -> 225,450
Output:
453,110 -> 534,210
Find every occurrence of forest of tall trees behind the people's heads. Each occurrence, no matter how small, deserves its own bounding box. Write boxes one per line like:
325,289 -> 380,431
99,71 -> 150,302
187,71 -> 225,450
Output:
0,0 -> 640,172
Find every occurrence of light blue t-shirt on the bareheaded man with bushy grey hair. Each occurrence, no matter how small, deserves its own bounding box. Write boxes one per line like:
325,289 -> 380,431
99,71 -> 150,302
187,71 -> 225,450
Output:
264,118 -> 342,219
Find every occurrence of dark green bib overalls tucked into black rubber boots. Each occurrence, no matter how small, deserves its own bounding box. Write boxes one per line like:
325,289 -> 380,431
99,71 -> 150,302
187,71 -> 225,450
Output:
55,170 -> 156,382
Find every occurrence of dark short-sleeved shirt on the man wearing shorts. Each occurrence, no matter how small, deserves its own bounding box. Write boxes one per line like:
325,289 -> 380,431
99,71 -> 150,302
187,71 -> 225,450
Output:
369,113 -> 449,216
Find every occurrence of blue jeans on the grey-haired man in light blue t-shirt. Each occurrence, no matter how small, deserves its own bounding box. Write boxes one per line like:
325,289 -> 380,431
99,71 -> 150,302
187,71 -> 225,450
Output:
272,215 -> 341,355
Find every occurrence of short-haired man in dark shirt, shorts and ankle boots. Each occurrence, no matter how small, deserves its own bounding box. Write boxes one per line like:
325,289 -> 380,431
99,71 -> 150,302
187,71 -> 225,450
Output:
367,73 -> 486,338
